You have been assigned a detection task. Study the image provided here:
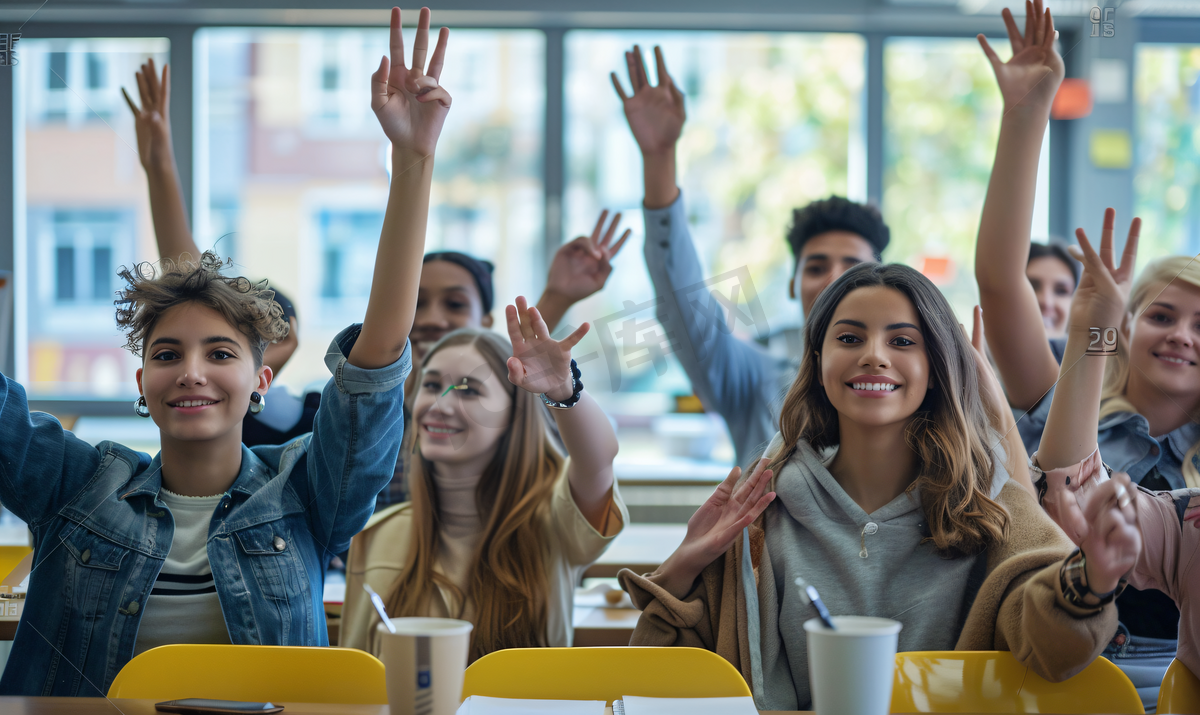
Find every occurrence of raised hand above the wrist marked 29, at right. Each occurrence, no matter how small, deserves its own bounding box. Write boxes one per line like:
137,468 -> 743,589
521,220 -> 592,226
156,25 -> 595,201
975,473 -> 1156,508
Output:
1070,209 -> 1141,328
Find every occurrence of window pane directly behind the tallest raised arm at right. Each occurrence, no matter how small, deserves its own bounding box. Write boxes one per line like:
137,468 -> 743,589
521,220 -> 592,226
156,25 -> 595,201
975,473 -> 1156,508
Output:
883,37 -> 1049,323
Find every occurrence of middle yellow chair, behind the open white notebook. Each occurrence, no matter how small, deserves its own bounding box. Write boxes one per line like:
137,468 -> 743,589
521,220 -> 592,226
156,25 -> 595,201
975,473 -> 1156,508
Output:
462,647 -> 750,705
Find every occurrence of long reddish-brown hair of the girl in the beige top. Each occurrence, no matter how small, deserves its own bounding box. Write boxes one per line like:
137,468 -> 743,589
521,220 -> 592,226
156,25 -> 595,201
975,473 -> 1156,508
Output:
386,329 -> 563,661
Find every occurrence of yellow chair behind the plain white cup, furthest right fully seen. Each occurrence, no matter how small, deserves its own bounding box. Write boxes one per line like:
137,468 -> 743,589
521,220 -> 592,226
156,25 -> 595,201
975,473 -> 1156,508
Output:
892,650 -> 1145,715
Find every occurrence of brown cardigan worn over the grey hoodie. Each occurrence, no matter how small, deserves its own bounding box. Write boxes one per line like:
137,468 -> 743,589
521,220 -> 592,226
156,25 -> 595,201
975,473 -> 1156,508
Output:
618,481 -> 1117,683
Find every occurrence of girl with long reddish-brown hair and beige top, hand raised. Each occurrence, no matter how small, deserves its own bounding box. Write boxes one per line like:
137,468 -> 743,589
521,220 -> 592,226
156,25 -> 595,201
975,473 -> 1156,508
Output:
340,298 -> 629,660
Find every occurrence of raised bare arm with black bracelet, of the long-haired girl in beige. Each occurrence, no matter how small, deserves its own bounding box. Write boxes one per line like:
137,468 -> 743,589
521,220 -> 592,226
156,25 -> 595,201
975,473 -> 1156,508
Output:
504,295 -> 618,531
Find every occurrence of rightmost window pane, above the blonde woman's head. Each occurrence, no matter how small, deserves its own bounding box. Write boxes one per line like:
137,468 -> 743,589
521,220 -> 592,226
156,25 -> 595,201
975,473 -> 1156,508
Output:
1134,43 -> 1200,257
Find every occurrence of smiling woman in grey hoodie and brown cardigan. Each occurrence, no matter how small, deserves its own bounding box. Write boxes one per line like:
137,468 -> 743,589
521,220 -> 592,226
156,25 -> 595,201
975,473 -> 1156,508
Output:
619,264 -> 1138,710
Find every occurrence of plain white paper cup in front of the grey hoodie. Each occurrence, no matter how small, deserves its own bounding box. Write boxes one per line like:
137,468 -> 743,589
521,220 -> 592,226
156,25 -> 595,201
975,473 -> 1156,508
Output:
804,615 -> 901,715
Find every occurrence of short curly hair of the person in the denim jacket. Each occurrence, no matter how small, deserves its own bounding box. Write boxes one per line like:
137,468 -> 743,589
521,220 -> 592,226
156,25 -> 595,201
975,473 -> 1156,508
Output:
115,251 -> 289,367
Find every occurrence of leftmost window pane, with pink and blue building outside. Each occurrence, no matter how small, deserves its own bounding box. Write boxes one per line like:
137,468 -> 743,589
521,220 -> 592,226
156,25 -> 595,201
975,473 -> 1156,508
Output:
14,37 -> 169,399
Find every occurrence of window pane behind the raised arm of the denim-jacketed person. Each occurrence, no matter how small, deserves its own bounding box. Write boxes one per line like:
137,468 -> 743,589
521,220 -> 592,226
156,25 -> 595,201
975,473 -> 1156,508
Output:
196,28 -> 546,387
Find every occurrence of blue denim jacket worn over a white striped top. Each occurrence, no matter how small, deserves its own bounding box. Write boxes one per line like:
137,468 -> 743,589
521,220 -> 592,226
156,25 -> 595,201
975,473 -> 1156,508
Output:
0,325 -> 412,697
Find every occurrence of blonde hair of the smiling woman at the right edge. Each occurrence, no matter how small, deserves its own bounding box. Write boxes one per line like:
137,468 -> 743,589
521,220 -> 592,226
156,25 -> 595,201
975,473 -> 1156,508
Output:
1100,256 -> 1200,487
